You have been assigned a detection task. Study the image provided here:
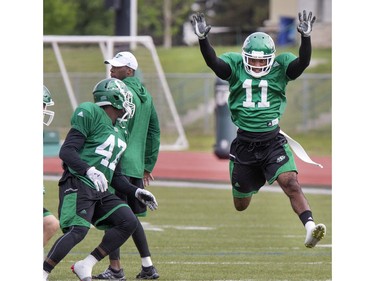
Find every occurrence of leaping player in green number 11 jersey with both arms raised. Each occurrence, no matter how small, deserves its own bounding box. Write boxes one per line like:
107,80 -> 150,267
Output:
191,11 -> 326,248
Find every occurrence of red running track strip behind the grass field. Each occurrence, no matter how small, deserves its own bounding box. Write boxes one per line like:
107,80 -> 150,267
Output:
44,151 -> 332,187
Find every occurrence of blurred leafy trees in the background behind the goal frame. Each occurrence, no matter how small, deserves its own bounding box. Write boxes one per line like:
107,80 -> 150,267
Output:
43,0 -> 269,47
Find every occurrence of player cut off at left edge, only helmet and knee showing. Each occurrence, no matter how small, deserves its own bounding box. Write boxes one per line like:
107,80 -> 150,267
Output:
43,85 -> 59,247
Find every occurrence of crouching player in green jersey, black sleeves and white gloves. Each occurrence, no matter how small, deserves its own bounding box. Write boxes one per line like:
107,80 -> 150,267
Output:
43,78 -> 158,281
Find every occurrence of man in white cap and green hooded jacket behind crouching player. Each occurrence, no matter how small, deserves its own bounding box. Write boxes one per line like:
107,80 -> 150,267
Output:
93,52 -> 160,280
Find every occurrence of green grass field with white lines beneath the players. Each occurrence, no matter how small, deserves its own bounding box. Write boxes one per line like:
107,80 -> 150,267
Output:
44,181 -> 332,281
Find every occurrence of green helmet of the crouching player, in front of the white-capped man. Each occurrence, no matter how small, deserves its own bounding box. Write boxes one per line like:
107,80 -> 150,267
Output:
92,78 -> 135,127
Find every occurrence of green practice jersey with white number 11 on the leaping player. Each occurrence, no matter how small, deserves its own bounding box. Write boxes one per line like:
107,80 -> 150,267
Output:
220,53 -> 296,132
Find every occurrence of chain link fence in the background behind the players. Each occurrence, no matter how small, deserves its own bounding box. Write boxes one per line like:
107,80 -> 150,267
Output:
44,73 -> 332,138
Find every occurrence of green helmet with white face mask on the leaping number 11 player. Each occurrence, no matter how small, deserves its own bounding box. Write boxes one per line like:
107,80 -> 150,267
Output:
242,32 -> 276,78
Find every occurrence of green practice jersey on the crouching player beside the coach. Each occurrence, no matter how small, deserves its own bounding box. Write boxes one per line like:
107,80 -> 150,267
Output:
69,102 -> 126,189
